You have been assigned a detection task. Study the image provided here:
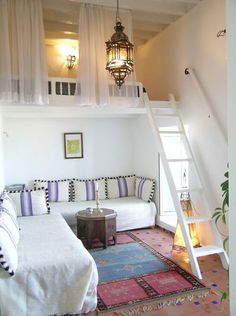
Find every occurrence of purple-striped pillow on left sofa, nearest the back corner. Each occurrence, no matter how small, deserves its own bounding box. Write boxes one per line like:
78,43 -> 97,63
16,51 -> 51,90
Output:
8,189 -> 50,216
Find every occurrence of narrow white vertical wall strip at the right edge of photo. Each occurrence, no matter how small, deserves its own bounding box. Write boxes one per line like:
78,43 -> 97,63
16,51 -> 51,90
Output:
227,0 -> 236,316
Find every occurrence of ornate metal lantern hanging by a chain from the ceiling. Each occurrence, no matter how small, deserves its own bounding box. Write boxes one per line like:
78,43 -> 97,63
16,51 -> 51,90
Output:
106,0 -> 134,87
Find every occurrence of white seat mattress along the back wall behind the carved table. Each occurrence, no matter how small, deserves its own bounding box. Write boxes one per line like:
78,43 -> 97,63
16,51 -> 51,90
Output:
50,196 -> 156,231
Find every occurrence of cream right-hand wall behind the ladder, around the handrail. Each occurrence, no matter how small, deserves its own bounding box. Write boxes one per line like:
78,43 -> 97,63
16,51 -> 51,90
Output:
136,0 -> 228,208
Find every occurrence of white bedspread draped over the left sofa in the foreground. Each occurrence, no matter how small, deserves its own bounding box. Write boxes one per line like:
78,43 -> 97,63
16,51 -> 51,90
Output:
0,214 -> 98,316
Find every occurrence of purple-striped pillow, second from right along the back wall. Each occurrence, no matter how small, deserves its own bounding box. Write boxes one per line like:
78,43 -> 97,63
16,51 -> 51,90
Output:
107,175 -> 135,199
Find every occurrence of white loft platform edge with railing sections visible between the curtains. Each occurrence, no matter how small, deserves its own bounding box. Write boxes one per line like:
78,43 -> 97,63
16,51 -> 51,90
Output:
0,77 -> 171,118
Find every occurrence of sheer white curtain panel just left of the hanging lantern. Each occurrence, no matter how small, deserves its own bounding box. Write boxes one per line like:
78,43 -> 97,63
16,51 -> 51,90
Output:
79,4 -> 109,106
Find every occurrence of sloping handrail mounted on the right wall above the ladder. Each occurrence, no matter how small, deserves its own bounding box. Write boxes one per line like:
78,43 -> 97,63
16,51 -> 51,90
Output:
185,68 -> 228,145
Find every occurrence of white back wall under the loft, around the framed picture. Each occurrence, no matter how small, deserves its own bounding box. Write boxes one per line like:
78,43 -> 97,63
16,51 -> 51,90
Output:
4,118 -> 135,188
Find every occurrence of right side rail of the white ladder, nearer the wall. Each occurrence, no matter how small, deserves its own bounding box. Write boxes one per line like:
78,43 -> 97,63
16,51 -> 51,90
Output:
169,94 -> 229,253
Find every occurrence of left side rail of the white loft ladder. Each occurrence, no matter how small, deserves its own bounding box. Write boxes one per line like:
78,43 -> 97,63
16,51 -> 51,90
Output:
144,95 -> 202,279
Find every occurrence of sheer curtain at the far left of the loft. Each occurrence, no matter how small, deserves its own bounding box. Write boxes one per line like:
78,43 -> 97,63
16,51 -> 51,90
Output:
0,0 -> 48,104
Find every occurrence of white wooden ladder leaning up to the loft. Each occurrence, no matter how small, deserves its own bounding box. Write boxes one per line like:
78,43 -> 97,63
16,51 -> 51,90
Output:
143,93 -> 229,279
